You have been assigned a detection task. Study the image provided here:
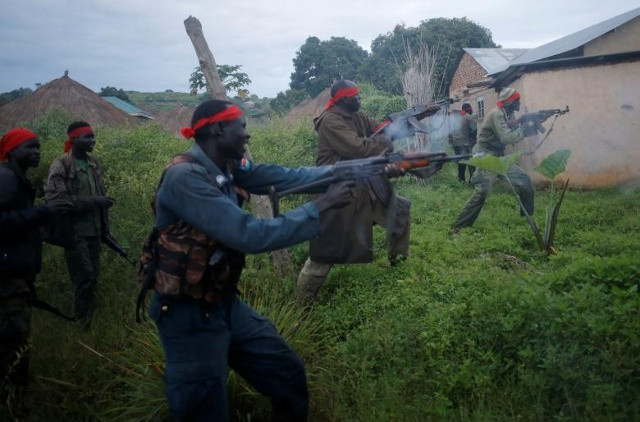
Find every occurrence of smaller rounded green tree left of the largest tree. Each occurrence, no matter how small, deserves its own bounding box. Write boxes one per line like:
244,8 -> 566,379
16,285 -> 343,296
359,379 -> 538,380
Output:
289,37 -> 368,97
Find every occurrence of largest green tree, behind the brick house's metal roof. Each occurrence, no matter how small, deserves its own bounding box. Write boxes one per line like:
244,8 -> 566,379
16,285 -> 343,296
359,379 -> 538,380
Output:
359,17 -> 498,97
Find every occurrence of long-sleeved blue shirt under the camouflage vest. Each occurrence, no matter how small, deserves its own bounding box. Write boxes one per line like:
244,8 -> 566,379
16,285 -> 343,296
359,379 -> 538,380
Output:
155,144 -> 332,253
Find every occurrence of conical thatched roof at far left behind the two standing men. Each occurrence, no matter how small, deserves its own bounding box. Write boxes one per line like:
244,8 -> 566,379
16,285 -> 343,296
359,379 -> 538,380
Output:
0,72 -> 137,127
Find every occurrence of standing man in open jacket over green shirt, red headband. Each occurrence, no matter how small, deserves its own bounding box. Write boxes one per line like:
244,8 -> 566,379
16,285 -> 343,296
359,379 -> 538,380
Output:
45,121 -> 114,329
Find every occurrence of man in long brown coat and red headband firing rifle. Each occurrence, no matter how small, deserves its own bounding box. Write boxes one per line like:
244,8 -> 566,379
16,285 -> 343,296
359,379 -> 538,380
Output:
295,80 -> 411,305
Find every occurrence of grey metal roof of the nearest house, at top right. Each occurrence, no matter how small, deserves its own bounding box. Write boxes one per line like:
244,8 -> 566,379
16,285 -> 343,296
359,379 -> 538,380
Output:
490,7 -> 640,74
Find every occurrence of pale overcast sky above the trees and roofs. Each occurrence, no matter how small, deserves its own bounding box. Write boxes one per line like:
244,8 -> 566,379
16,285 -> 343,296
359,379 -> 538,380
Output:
0,0 -> 640,97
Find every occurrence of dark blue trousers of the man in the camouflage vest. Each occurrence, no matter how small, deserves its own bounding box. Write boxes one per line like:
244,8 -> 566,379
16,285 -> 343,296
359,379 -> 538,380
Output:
149,293 -> 309,422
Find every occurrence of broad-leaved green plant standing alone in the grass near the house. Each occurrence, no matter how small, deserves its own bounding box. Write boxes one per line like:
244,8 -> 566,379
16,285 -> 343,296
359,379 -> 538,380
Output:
467,149 -> 571,254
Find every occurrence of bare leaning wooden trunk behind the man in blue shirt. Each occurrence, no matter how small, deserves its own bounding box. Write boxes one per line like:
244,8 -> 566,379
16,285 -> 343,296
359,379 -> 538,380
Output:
184,16 -> 293,274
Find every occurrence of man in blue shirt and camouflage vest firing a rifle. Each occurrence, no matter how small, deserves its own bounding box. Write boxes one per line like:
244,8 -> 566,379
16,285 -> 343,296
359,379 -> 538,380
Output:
144,100 -> 353,421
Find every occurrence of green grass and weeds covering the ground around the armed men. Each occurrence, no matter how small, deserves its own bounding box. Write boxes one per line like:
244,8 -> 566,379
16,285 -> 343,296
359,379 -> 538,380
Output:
2,114 -> 640,421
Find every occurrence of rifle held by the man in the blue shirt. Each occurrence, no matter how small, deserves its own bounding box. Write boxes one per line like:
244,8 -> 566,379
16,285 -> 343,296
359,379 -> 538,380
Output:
270,152 -> 472,216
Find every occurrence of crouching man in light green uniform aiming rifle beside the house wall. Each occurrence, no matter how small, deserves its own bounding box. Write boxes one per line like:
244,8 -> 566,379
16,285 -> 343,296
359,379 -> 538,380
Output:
451,87 -> 534,234
